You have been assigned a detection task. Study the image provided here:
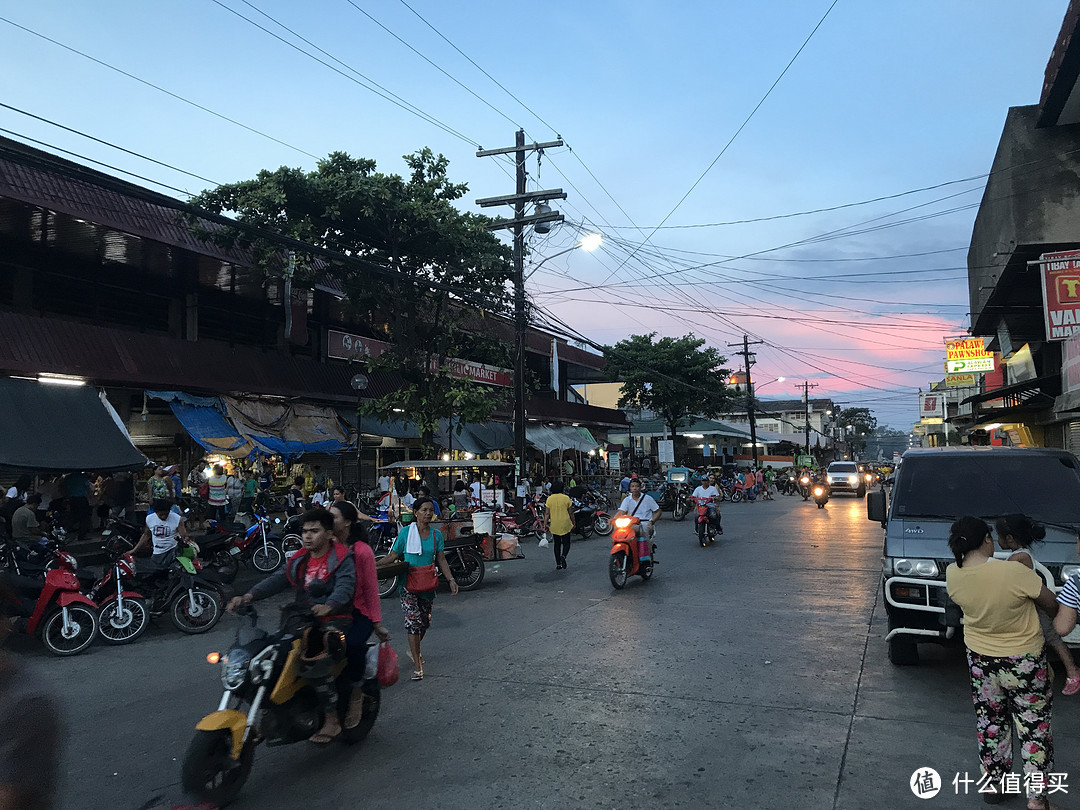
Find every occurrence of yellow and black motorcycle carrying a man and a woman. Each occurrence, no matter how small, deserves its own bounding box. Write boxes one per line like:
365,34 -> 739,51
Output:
180,605 -> 379,807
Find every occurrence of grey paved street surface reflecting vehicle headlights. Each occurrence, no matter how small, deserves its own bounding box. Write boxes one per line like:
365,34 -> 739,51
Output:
17,496 -> 1080,810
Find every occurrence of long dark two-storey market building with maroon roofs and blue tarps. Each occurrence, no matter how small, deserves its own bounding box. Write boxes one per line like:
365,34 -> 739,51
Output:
0,138 -> 625,485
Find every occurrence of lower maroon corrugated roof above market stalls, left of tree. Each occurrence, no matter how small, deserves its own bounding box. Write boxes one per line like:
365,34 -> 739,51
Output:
0,312 -> 397,403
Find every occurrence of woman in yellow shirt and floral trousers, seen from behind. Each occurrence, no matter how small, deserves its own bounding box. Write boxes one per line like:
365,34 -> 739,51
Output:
945,516 -> 1057,810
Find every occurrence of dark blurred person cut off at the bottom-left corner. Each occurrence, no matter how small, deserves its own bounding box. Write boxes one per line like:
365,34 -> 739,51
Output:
0,573 -> 64,810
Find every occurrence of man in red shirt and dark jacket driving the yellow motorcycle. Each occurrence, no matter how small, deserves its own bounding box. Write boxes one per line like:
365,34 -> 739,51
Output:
227,507 -> 356,745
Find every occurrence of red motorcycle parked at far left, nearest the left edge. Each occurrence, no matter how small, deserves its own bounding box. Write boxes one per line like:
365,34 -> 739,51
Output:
8,552 -> 97,656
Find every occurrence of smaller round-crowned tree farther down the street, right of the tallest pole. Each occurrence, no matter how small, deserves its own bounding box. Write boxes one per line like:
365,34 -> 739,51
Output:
604,332 -> 732,436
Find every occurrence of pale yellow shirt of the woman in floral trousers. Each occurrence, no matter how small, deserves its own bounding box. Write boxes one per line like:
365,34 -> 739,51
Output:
945,559 -> 1042,658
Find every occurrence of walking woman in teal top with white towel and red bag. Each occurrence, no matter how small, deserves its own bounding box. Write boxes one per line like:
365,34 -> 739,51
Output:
373,498 -> 458,680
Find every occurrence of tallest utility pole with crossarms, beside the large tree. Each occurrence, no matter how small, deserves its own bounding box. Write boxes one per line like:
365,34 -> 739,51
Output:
476,130 -> 566,498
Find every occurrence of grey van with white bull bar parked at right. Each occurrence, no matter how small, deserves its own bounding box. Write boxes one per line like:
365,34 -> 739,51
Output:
866,447 -> 1080,666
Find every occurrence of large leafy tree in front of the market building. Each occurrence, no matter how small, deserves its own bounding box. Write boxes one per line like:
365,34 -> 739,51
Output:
192,149 -> 512,451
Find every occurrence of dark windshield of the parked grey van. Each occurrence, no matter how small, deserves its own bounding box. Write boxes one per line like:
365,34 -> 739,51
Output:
893,453 -> 1080,524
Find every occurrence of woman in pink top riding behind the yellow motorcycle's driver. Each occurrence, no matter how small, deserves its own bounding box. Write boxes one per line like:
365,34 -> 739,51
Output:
329,500 -> 390,729
